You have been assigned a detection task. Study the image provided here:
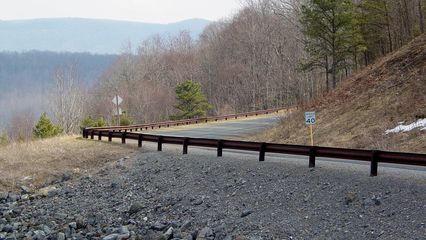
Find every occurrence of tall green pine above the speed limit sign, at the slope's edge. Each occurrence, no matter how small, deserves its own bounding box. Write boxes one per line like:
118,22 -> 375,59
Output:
301,0 -> 365,90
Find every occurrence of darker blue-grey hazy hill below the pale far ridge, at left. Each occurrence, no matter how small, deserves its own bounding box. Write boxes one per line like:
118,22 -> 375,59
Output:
0,51 -> 117,125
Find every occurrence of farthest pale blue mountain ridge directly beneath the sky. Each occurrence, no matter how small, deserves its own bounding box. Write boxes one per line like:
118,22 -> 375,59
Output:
0,18 -> 210,54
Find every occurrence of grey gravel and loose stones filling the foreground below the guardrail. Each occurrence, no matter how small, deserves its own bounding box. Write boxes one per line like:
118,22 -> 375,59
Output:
0,143 -> 426,240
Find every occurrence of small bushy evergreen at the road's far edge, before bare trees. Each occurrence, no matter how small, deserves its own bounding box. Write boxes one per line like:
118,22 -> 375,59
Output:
171,80 -> 212,120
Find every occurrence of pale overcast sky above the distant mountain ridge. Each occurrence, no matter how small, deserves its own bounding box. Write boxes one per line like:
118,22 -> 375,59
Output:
0,0 -> 241,23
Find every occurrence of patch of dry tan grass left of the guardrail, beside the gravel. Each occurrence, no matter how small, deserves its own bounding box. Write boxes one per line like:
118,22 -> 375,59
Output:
0,136 -> 137,192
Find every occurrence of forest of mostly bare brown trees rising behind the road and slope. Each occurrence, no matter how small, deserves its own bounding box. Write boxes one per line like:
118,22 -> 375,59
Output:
1,0 -> 426,141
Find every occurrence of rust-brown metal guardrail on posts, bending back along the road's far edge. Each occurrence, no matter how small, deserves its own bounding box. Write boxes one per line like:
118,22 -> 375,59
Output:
83,109 -> 426,176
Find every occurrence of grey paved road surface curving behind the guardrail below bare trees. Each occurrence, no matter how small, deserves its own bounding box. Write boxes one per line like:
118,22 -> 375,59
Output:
146,114 -> 282,139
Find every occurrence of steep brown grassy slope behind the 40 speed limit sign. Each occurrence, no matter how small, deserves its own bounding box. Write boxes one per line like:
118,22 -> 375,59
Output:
255,35 -> 426,153
